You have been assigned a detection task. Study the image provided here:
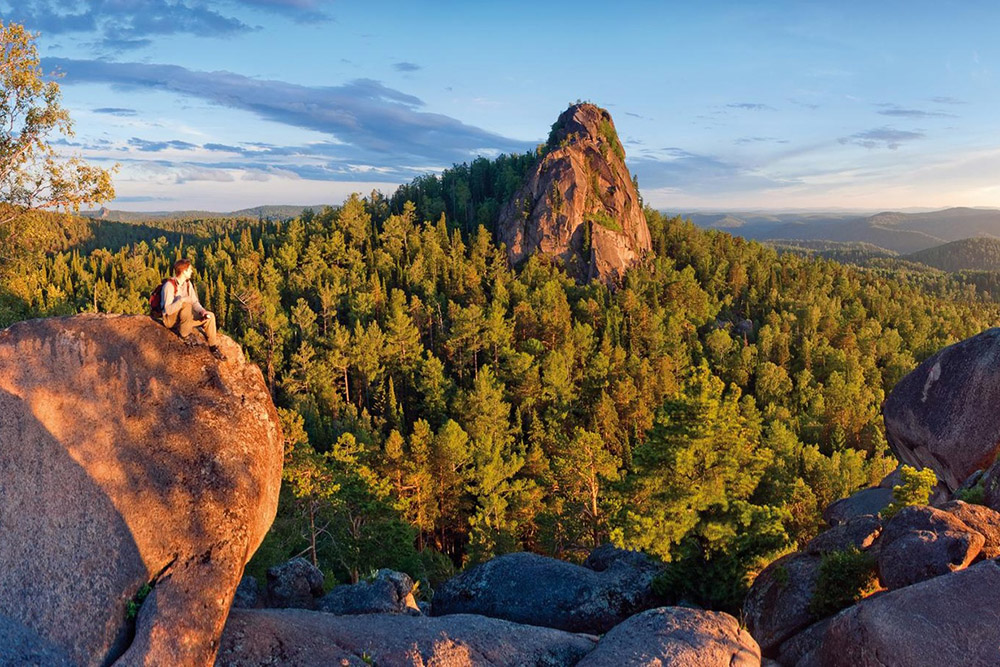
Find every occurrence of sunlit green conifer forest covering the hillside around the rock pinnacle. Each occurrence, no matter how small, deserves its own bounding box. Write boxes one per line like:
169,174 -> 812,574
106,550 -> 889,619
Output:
0,175 -> 998,609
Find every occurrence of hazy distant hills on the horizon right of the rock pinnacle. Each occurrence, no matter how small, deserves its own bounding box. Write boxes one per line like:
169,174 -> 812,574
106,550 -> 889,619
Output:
684,207 -> 1000,255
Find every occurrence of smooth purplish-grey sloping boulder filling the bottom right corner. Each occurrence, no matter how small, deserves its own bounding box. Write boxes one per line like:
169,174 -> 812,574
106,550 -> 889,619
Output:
816,560 -> 1000,667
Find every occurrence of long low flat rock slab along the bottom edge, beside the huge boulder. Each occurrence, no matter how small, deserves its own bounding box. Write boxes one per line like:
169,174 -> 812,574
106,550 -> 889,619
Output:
216,609 -> 595,667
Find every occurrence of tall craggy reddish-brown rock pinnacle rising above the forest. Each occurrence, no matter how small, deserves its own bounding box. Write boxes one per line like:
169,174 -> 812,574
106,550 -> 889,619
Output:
499,104 -> 652,280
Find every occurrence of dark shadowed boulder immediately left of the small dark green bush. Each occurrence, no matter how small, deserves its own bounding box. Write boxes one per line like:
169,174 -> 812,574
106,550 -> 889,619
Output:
743,553 -> 820,653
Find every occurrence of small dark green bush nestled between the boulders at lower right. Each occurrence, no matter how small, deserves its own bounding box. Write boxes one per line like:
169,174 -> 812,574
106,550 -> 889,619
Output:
809,547 -> 878,619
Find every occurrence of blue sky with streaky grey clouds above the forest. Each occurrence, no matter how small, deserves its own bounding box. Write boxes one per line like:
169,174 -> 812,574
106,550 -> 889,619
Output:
0,0 -> 1000,212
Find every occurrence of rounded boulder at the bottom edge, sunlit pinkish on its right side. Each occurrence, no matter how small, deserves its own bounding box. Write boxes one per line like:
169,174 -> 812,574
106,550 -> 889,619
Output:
577,607 -> 760,667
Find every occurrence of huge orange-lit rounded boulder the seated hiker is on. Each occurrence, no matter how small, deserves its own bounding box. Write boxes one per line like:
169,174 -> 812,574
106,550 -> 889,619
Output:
0,315 -> 282,665
